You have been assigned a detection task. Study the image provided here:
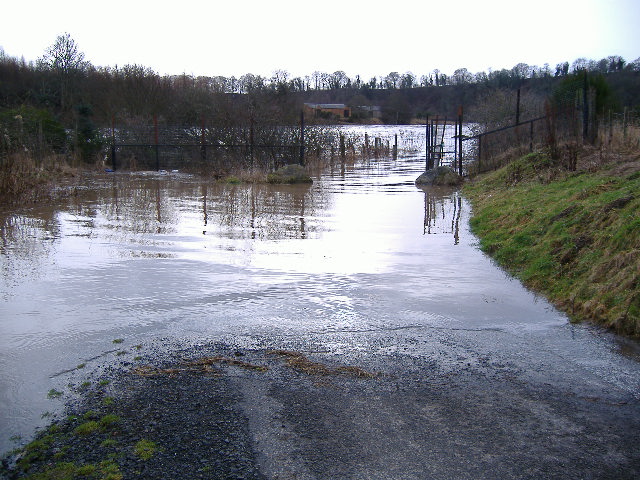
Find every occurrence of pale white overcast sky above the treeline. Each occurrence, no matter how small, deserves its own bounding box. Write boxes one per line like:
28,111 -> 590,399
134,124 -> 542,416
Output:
0,0 -> 640,80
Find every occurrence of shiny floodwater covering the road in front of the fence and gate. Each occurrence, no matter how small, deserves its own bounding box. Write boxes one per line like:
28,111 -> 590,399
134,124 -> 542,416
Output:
0,127 -> 640,451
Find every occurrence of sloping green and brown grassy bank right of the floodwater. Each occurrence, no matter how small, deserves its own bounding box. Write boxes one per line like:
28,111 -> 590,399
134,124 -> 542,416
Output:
464,150 -> 640,337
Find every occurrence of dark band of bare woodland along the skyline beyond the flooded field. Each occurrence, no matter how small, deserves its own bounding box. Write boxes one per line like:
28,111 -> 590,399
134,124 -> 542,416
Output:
0,34 -> 640,161
